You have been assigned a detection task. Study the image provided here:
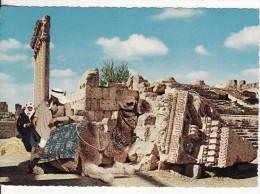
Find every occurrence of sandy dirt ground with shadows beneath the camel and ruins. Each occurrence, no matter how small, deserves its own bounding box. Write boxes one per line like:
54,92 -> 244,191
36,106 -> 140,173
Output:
0,139 -> 258,188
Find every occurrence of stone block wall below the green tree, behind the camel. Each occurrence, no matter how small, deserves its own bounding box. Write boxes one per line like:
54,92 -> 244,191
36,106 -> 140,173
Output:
67,69 -> 139,121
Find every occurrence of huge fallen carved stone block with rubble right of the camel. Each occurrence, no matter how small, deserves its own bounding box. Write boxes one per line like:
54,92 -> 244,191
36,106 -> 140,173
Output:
123,76 -> 257,170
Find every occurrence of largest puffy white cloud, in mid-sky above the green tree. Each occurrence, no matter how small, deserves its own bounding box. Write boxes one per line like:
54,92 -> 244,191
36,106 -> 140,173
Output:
96,34 -> 168,60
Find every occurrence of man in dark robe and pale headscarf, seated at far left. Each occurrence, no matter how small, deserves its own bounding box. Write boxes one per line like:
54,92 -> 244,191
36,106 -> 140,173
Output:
16,102 -> 40,152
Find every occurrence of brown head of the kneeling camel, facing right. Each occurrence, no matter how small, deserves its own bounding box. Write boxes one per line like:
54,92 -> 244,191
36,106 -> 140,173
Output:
118,99 -> 150,115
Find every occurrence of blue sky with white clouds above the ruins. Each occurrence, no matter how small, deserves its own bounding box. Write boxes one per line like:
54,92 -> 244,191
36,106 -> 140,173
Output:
0,7 -> 260,111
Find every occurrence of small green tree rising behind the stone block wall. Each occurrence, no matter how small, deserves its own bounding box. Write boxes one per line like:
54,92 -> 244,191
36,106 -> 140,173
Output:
100,59 -> 130,87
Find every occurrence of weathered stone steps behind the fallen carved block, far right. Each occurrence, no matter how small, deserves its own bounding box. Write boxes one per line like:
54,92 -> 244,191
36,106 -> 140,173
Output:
193,90 -> 259,148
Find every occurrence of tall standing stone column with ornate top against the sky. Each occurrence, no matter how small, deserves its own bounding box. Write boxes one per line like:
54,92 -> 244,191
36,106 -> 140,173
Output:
30,15 -> 50,106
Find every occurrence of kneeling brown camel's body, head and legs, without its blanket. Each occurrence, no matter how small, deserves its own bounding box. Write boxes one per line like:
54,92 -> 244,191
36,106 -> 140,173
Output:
33,99 -> 150,183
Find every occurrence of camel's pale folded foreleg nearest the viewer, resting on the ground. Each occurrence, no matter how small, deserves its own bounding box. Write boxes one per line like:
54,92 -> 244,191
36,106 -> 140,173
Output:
84,163 -> 114,183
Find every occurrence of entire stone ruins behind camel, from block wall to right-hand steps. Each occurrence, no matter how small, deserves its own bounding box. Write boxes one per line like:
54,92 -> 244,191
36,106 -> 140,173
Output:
68,69 -> 258,174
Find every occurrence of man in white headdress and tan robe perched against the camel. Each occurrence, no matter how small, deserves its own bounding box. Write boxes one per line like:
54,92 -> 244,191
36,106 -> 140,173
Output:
33,88 -> 72,158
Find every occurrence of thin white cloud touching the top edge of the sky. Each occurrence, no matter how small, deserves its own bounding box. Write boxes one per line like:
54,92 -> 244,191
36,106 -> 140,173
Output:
153,8 -> 203,20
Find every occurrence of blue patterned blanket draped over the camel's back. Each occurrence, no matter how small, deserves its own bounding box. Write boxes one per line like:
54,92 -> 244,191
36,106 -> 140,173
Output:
38,123 -> 83,163
